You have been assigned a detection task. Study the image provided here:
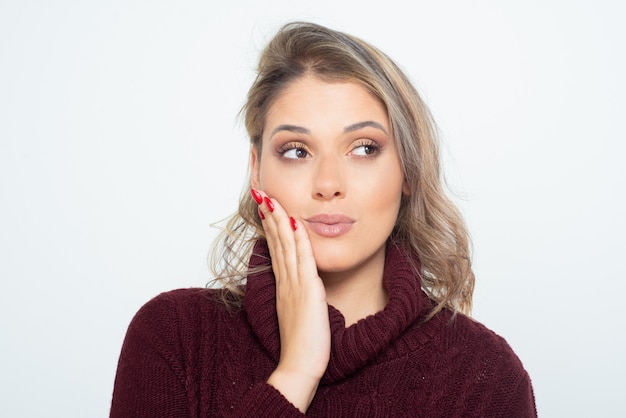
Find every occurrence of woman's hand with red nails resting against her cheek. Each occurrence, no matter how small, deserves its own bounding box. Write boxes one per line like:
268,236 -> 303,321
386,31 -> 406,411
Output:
252,190 -> 330,413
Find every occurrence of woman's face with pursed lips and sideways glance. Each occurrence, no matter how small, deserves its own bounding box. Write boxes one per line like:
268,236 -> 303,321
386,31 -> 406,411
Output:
251,76 -> 406,278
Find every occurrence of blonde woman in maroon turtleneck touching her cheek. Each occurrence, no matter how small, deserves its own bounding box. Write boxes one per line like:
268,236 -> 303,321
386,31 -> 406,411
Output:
111,23 -> 536,417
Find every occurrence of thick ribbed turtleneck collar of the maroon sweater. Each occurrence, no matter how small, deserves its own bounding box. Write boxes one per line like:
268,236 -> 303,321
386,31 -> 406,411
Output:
244,240 -> 430,384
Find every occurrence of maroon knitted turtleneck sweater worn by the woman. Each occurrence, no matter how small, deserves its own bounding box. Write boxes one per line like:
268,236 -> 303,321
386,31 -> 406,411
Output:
111,244 -> 536,418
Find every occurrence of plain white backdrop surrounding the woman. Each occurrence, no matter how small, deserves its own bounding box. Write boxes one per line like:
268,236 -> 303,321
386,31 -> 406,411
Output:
0,0 -> 626,417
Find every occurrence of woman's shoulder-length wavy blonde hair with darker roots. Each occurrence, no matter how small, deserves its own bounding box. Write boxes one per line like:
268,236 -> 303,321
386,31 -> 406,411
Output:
211,22 -> 474,318
